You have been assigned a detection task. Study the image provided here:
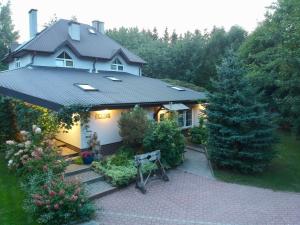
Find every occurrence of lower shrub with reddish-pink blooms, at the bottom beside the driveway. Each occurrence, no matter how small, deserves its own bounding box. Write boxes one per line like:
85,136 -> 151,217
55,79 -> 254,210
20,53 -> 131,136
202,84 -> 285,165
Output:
24,171 -> 95,225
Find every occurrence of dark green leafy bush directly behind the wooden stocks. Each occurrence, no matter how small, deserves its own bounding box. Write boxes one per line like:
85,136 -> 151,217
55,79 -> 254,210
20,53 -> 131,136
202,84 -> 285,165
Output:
144,120 -> 185,167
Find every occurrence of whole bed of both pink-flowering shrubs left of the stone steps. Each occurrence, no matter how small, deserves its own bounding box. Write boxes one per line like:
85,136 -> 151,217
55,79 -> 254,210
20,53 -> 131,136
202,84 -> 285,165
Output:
6,126 -> 95,225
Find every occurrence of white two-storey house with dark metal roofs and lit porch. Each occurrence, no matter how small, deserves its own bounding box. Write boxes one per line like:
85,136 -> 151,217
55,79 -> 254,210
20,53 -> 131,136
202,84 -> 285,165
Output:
0,9 -> 205,151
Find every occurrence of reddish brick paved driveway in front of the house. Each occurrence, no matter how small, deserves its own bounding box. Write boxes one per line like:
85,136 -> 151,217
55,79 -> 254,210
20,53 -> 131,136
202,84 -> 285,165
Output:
96,170 -> 300,225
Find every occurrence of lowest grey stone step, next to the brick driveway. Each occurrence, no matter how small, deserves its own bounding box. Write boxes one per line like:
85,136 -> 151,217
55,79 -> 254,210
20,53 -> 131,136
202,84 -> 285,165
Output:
86,180 -> 118,200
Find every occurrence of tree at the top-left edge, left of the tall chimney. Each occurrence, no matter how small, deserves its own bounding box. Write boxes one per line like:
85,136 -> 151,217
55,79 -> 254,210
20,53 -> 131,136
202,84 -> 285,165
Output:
0,1 -> 19,71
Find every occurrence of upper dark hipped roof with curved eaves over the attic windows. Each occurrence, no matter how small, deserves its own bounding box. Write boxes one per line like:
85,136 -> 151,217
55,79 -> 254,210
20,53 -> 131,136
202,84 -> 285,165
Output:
5,19 -> 146,64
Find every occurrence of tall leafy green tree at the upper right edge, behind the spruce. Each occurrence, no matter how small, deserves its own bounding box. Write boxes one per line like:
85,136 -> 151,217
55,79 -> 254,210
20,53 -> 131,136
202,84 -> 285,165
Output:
240,0 -> 300,134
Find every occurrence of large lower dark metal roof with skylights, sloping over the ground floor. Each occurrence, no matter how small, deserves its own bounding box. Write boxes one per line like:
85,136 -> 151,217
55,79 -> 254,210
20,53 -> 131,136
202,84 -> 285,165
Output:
0,66 -> 206,110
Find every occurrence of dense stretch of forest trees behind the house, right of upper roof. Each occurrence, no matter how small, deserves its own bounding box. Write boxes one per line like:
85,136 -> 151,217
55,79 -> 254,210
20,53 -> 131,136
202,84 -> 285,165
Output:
107,26 -> 247,88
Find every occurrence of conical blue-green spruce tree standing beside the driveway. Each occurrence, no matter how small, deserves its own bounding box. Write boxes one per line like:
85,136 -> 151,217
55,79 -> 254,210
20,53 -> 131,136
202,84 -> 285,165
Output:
207,53 -> 275,173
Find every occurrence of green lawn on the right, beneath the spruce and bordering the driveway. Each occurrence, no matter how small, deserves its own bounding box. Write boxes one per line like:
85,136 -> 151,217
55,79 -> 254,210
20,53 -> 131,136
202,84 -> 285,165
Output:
214,133 -> 300,192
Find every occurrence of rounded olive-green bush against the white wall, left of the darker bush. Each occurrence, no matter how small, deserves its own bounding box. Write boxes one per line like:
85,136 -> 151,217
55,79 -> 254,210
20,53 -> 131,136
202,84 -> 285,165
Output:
118,106 -> 149,147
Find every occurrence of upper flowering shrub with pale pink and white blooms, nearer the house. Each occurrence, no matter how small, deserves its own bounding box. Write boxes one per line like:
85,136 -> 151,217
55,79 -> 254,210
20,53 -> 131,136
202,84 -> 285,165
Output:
6,125 -> 66,175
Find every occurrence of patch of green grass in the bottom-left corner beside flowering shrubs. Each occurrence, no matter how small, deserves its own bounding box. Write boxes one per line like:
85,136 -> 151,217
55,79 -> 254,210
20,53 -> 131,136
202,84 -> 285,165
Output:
0,153 -> 36,225
